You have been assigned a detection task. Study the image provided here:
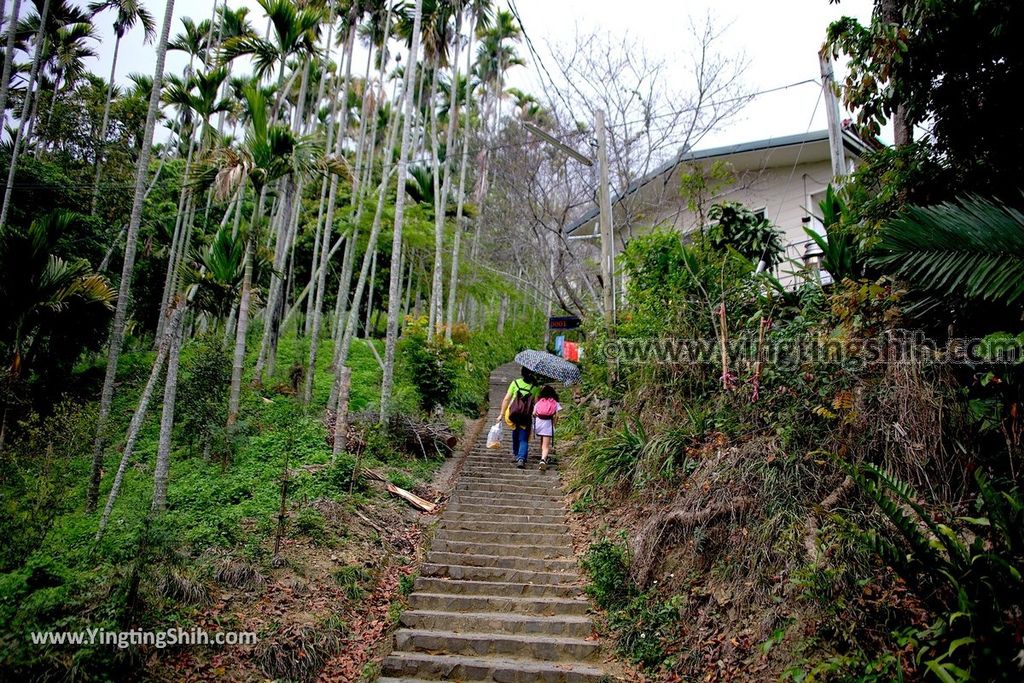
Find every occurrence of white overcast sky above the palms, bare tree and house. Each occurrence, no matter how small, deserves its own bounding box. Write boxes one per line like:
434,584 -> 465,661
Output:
28,0 -> 886,147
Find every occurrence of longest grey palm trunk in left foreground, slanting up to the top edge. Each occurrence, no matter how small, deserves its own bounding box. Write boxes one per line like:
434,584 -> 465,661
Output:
88,0 -> 174,511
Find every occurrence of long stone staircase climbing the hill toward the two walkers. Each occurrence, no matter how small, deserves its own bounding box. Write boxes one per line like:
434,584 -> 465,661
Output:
378,365 -> 613,683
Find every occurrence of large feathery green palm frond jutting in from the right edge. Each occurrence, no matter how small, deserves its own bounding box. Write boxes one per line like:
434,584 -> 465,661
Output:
870,197 -> 1024,306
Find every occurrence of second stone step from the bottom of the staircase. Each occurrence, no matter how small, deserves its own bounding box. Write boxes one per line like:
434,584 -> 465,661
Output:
394,629 -> 597,661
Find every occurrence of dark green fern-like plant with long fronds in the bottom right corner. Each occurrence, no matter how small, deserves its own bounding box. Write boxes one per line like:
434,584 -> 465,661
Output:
848,465 -> 1024,683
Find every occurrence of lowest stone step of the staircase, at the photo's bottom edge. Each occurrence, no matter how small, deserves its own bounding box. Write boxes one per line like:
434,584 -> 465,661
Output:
383,652 -> 607,683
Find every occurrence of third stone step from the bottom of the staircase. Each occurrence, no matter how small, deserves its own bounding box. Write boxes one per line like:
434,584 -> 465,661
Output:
401,609 -> 594,638
